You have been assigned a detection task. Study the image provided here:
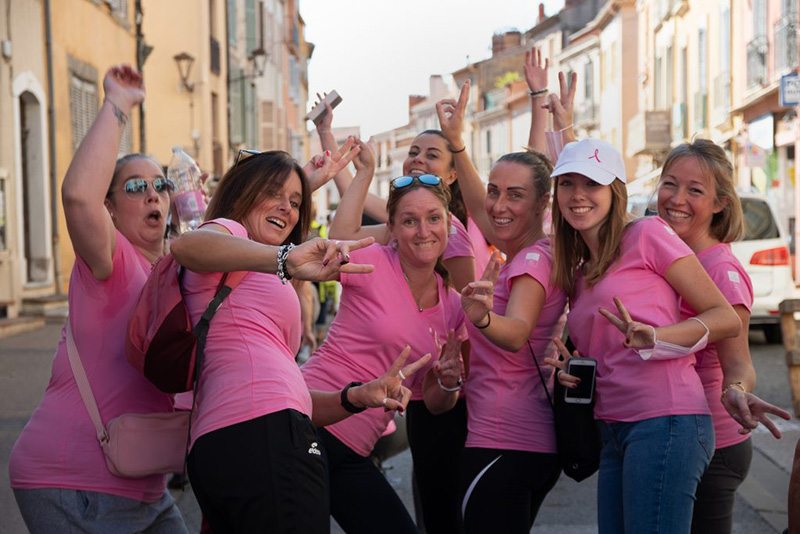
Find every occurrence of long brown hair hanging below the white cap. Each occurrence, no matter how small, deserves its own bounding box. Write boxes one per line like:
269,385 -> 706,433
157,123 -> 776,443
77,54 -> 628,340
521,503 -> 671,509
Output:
553,178 -> 629,296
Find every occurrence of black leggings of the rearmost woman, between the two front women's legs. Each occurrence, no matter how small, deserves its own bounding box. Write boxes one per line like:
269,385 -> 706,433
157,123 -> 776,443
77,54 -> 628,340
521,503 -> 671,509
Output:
407,398 -> 467,534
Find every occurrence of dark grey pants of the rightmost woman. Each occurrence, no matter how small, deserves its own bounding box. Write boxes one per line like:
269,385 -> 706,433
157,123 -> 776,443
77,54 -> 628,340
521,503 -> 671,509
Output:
692,439 -> 753,534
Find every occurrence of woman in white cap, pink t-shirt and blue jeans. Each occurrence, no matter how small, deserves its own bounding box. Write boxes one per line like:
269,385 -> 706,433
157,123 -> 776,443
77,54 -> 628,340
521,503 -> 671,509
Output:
549,139 -> 741,533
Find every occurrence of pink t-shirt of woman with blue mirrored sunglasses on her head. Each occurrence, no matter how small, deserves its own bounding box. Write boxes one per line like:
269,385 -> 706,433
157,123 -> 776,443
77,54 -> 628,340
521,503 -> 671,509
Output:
302,245 -> 464,456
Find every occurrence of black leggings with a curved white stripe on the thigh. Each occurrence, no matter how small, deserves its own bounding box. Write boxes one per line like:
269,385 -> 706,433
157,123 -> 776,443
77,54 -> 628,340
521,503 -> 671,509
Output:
462,447 -> 561,534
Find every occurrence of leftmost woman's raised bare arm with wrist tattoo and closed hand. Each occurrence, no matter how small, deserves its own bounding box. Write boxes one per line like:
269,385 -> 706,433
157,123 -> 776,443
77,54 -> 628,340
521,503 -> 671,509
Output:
61,65 -> 145,280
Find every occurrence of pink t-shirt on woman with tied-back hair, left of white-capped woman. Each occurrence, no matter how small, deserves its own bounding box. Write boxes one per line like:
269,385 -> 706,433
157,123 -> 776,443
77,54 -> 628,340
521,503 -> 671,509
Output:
467,239 -> 567,453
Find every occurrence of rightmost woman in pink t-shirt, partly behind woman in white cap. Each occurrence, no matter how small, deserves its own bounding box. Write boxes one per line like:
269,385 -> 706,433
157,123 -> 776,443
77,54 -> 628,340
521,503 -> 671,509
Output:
658,139 -> 790,534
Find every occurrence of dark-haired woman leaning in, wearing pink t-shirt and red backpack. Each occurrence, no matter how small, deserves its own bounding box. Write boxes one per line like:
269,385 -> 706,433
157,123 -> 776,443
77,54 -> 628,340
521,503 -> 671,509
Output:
171,150 -> 429,533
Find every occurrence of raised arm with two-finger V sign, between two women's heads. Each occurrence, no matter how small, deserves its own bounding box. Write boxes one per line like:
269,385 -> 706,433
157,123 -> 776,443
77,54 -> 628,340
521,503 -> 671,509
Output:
436,80 -> 496,247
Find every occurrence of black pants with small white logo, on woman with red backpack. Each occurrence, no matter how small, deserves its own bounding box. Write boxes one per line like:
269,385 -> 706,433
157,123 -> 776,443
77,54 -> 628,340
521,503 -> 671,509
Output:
188,410 -> 331,534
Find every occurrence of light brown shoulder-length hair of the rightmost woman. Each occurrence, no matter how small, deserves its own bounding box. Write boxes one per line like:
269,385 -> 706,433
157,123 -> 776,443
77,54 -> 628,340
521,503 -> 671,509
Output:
659,139 -> 744,243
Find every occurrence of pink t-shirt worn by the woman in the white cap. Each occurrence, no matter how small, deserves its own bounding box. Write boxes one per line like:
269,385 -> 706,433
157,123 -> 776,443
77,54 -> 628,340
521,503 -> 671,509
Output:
567,217 -> 709,422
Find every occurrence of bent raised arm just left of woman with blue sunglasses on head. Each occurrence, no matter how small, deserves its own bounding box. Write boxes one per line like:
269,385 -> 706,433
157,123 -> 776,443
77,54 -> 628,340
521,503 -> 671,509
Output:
329,140 -> 389,244
